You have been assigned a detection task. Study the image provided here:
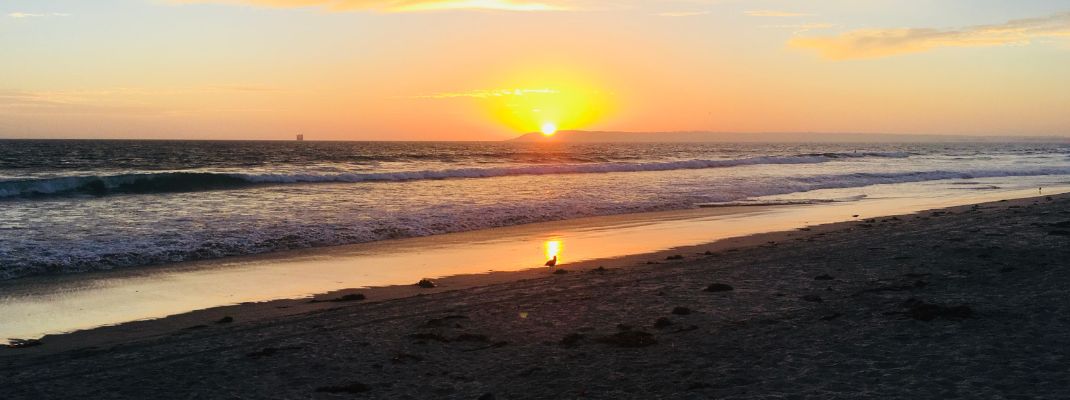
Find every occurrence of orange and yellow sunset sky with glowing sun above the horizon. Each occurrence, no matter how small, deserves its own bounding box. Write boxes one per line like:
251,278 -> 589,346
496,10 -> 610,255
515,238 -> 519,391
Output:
0,0 -> 1070,140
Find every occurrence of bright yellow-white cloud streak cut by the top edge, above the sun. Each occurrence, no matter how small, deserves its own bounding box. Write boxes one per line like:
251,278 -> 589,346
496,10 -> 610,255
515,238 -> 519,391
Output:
172,0 -> 571,13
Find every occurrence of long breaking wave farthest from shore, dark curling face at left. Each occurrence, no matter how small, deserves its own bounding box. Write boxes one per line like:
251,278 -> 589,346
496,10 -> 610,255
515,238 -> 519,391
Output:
0,153 -> 910,199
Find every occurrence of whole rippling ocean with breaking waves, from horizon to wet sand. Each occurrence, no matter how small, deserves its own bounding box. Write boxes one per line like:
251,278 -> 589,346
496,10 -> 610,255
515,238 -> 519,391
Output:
0,140 -> 1070,280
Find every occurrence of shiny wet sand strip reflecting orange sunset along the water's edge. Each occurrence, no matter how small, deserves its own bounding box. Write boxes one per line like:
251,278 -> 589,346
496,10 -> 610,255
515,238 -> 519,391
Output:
6,185 -> 1070,348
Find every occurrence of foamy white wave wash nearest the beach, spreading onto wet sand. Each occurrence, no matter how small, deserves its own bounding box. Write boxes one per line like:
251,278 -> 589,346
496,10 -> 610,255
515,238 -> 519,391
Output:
0,163 -> 1070,280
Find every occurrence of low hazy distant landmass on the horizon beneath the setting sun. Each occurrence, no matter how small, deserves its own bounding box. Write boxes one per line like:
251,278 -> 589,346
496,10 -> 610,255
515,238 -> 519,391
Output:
510,130 -> 1070,143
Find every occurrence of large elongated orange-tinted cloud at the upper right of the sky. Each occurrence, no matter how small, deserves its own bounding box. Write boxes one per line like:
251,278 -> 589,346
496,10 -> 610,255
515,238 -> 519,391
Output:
789,13 -> 1070,60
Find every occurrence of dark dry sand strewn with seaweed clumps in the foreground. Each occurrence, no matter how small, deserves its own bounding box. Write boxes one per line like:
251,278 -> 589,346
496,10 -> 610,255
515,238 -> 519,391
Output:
0,192 -> 1070,399
